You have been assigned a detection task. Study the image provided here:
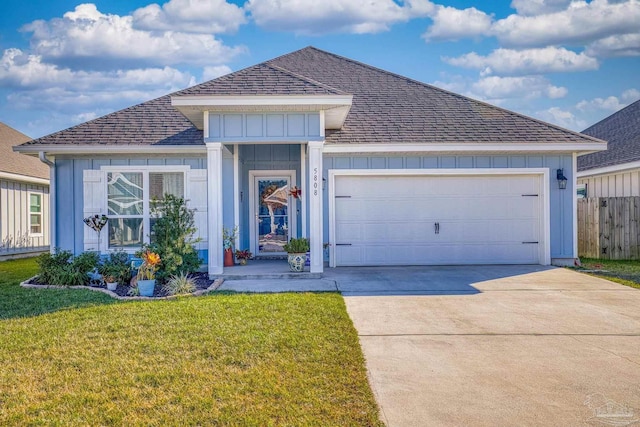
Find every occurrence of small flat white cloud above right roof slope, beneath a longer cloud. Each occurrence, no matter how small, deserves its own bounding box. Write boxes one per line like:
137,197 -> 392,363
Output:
470,76 -> 568,100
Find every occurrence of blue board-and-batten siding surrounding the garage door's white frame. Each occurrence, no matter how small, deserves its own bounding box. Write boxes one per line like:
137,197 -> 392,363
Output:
323,154 -> 575,260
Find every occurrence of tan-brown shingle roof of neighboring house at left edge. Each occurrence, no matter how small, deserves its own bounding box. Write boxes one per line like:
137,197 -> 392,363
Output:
0,122 -> 49,179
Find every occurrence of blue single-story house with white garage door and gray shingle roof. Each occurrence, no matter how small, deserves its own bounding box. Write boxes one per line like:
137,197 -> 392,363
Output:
13,47 -> 606,275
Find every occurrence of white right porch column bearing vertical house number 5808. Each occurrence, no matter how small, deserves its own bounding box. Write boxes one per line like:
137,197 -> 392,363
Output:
307,141 -> 324,273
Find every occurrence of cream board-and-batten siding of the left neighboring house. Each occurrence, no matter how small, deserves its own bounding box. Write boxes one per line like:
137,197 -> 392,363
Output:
0,179 -> 50,253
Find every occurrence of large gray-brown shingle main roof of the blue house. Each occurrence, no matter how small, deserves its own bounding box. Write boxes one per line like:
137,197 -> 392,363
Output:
18,47 -> 599,149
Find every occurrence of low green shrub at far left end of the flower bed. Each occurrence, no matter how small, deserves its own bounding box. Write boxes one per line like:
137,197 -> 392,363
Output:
37,249 -> 99,286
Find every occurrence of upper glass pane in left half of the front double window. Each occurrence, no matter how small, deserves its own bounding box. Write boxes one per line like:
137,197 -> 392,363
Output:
107,172 -> 144,216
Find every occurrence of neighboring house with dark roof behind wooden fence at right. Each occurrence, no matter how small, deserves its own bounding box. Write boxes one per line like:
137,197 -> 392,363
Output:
578,100 -> 640,197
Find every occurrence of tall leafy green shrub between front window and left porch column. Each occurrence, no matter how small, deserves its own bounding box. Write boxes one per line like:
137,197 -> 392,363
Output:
145,194 -> 201,283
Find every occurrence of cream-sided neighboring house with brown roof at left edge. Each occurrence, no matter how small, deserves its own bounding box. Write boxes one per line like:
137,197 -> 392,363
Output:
0,123 -> 49,258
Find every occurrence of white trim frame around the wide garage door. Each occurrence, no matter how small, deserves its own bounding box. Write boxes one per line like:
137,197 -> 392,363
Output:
329,168 -> 551,267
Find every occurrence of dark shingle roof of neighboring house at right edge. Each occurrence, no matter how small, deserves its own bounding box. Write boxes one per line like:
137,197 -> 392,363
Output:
578,100 -> 640,171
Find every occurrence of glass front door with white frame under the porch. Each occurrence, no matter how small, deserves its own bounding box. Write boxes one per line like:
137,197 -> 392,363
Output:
250,171 -> 295,256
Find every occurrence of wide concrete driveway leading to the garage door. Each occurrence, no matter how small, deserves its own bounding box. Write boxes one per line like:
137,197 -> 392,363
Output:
336,266 -> 640,427
